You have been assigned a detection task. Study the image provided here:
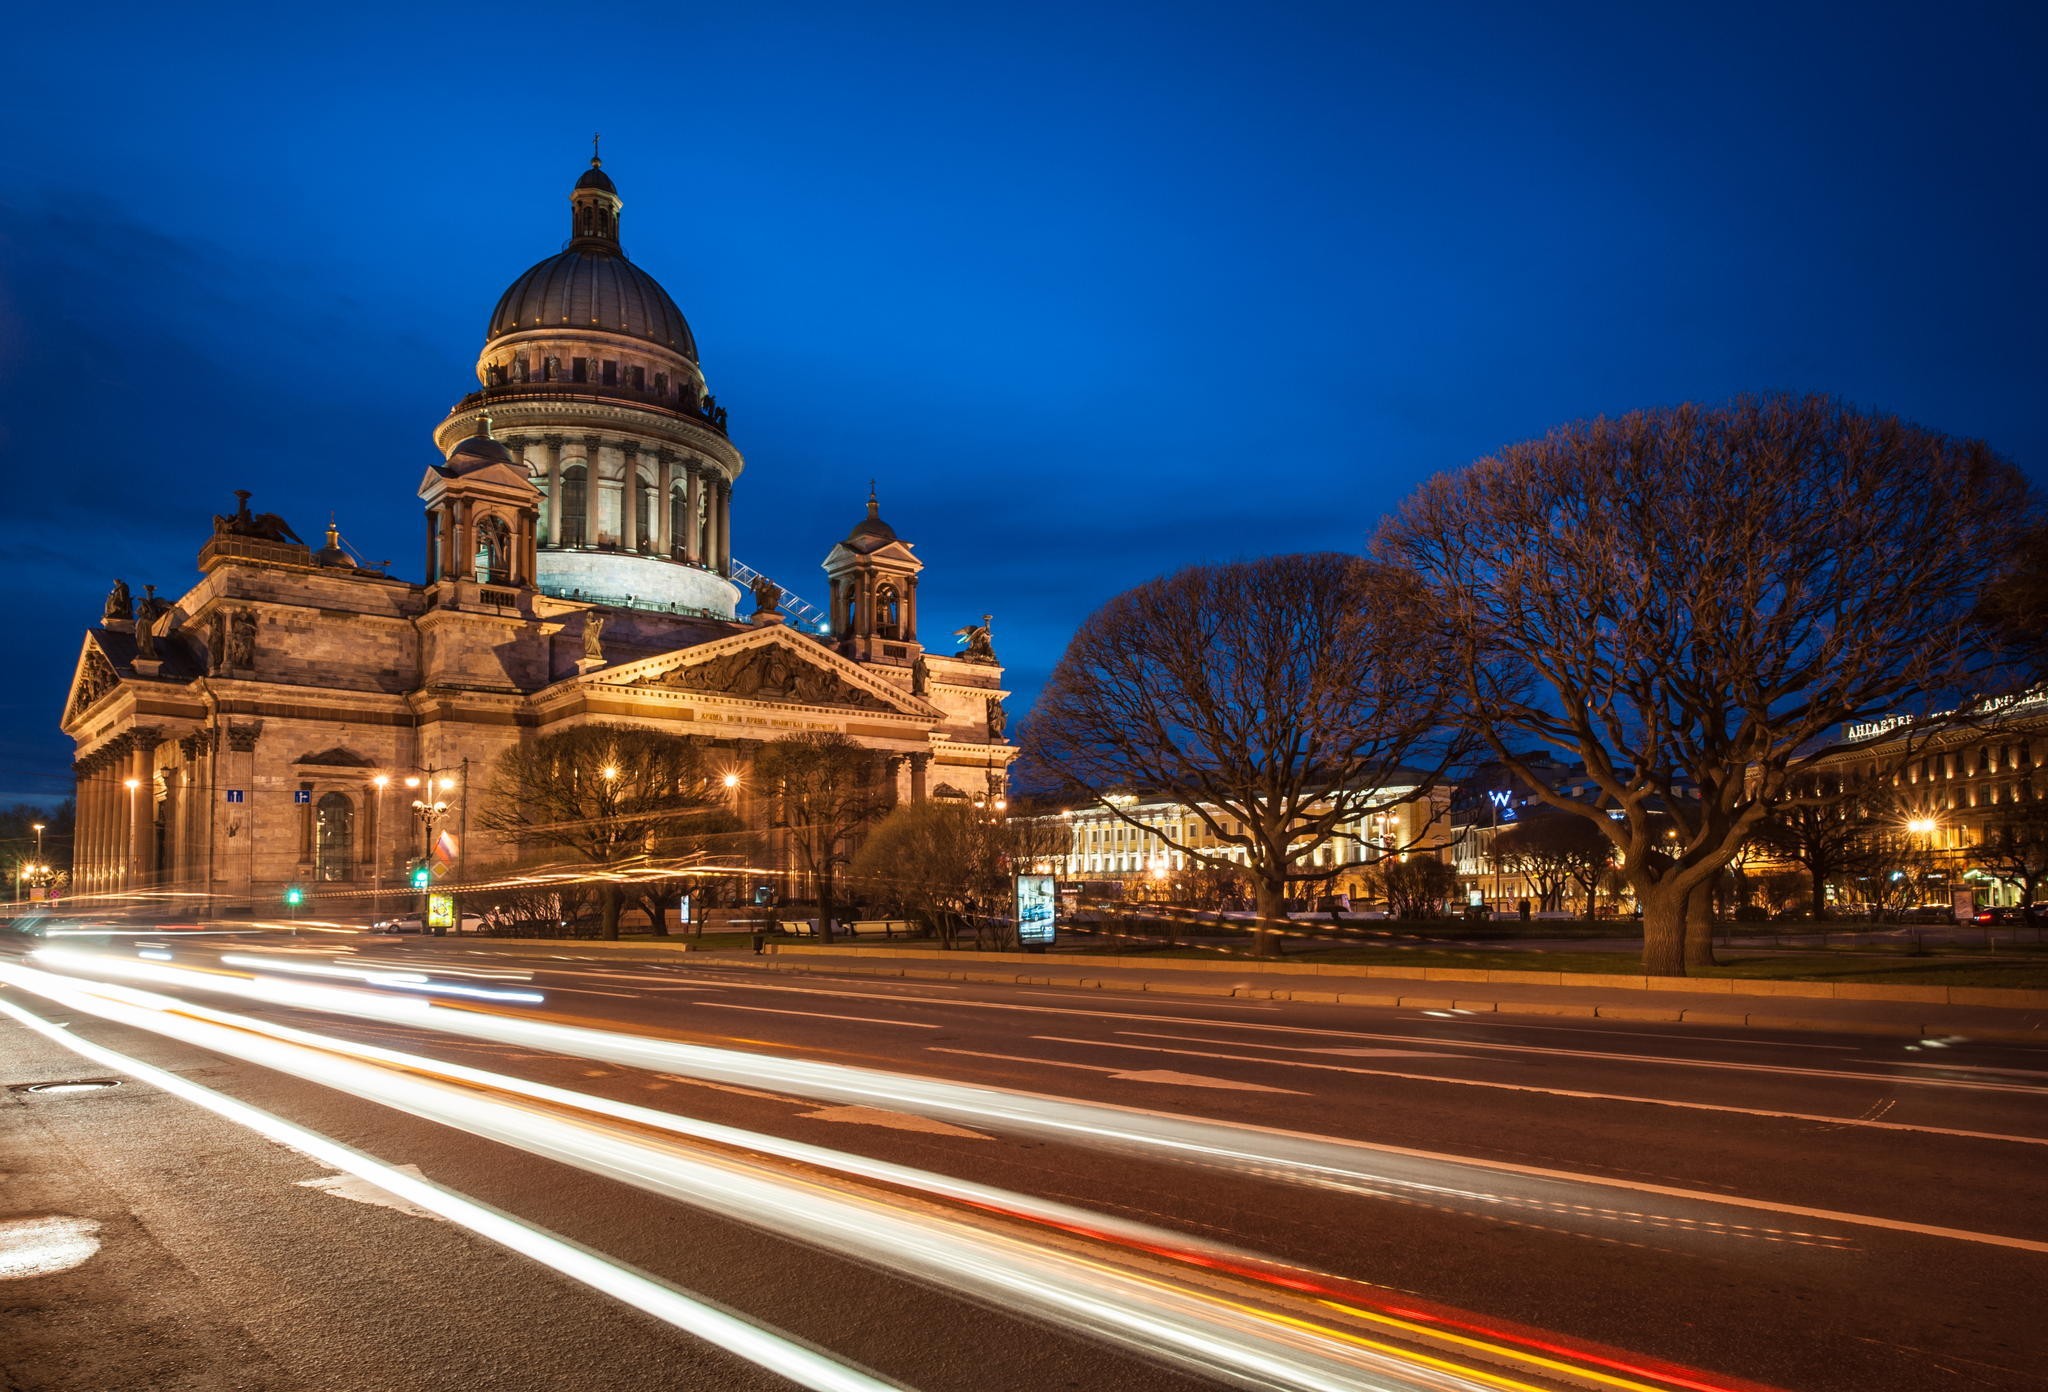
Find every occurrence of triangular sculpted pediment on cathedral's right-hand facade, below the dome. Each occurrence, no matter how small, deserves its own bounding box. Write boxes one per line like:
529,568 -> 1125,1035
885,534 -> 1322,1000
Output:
586,624 -> 942,721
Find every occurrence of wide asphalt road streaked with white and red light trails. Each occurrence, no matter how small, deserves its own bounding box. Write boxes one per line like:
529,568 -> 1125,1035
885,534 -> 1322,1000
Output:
0,936 -> 2048,1392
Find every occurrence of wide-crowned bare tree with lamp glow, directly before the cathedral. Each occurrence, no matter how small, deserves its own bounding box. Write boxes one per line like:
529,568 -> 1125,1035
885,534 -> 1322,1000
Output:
477,725 -> 733,938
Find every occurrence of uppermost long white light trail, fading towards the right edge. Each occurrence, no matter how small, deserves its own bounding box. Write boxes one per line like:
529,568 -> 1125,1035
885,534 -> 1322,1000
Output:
19,948 -> 2048,1253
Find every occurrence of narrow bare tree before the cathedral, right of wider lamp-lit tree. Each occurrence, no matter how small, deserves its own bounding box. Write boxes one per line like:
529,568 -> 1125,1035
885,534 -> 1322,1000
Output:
754,733 -> 895,942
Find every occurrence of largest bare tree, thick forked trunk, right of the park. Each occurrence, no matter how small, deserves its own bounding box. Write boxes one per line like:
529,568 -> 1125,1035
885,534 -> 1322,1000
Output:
1376,397 -> 2032,974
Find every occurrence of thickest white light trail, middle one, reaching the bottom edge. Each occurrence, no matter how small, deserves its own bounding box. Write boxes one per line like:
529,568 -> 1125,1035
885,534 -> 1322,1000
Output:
6,970 -> 1662,1392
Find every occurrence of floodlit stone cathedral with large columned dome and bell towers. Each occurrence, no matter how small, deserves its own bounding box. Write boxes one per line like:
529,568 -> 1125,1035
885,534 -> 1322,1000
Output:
63,158 -> 1014,915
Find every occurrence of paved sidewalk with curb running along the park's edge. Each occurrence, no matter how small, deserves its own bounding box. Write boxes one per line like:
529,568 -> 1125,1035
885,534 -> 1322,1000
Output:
692,944 -> 2048,1046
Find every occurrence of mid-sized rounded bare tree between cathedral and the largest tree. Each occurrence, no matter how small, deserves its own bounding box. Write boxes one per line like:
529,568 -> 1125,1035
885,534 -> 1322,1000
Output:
1024,553 -> 1458,952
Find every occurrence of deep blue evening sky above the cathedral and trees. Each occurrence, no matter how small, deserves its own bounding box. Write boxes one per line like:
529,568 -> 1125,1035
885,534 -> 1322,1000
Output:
0,2 -> 2048,802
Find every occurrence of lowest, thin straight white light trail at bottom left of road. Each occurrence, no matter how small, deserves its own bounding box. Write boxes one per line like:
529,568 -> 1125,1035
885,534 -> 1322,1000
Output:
0,999 -> 899,1392
